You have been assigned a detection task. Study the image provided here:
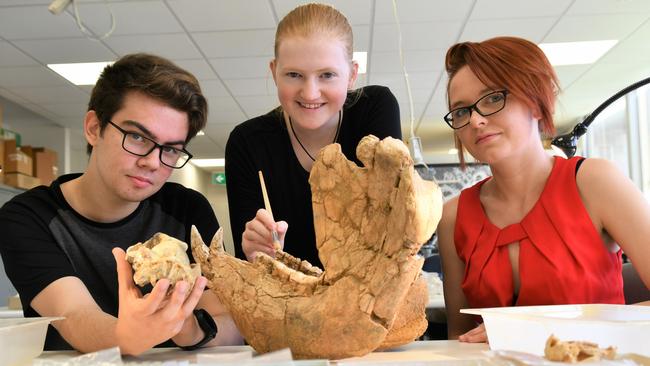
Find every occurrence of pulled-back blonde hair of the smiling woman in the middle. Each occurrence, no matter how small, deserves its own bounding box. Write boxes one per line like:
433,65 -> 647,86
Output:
274,3 -> 353,61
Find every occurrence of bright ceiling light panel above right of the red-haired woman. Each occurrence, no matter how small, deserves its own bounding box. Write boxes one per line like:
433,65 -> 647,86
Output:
539,39 -> 618,66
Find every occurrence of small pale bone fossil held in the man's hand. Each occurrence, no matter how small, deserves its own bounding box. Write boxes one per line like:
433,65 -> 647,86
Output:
126,233 -> 201,288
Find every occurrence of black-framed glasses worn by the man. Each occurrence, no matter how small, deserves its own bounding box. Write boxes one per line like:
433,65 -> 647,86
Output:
108,121 -> 192,169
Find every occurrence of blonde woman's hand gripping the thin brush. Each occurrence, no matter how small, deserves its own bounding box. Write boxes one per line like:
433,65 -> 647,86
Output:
242,208 -> 289,262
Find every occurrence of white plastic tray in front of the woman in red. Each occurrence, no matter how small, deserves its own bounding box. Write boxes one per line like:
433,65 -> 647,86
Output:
460,304 -> 650,356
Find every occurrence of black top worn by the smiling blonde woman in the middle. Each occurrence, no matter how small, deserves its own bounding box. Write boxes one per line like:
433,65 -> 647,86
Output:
226,86 -> 402,267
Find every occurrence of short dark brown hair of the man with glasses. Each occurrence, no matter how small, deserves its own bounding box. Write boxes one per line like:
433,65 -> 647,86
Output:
87,53 -> 208,154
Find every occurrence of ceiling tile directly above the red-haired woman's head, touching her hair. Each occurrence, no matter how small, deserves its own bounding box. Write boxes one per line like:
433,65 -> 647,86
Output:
460,17 -> 557,43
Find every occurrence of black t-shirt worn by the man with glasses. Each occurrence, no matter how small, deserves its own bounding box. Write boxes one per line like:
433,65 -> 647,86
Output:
0,174 -> 219,349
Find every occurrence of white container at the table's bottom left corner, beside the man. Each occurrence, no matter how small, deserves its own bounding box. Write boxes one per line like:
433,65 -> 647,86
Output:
0,318 -> 63,366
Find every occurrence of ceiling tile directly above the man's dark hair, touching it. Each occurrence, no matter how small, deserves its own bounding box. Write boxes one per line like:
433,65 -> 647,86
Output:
105,33 -> 202,60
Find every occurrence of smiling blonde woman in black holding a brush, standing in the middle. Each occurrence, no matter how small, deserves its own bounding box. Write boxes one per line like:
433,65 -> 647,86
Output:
226,4 -> 401,266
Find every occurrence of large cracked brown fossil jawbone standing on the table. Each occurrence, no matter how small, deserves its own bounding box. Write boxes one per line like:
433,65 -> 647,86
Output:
192,136 -> 442,359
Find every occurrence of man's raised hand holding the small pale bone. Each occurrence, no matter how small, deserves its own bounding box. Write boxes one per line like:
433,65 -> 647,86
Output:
113,248 -> 207,355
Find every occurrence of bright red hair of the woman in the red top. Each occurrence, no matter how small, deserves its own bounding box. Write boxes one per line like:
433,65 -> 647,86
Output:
445,37 -> 560,165
